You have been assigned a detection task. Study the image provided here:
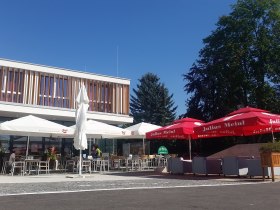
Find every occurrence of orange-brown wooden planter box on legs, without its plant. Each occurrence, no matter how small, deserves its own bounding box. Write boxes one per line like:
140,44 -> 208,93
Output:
260,152 -> 280,182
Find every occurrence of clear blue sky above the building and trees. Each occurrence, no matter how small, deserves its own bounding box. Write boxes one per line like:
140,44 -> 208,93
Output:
0,0 -> 236,115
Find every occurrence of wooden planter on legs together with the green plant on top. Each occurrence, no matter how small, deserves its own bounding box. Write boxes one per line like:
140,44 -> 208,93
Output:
259,142 -> 280,182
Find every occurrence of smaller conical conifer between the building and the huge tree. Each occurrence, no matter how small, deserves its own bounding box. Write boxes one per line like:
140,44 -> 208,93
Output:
130,73 -> 177,126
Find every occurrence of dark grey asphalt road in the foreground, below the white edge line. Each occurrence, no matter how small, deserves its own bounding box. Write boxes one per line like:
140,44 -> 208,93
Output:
0,182 -> 280,210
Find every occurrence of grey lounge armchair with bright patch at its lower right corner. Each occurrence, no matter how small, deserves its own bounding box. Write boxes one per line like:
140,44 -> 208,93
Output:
222,157 -> 249,177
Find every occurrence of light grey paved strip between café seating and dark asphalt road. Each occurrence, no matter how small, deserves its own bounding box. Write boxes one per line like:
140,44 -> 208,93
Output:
0,172 -> 270,196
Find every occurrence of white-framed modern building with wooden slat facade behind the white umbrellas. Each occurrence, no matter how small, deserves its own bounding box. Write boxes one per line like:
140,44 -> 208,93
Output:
0,59 -> 133,159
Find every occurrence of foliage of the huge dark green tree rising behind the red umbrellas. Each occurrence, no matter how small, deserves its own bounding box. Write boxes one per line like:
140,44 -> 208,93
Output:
184,0 -> 280,120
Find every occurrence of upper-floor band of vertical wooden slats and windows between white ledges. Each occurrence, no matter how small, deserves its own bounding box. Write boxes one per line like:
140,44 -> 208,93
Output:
0,66 -> 130,115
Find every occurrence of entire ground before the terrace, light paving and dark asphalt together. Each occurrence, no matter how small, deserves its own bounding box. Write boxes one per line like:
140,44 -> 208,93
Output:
0,173 -> 280,210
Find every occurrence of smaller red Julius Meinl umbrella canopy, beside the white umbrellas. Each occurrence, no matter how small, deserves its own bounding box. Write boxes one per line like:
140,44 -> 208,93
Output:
146,118 -> 203,139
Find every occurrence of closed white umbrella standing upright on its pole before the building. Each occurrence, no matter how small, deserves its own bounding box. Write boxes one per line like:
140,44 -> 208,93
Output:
74,84 -> 89,175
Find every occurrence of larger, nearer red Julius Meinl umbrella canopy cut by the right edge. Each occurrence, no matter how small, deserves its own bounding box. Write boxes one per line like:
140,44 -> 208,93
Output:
194,107 -> 280,138
